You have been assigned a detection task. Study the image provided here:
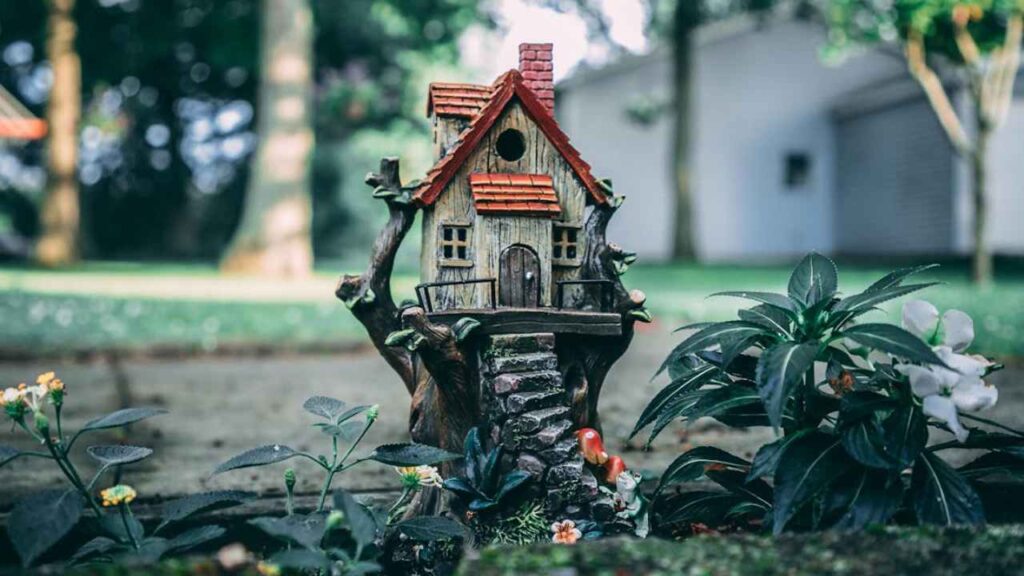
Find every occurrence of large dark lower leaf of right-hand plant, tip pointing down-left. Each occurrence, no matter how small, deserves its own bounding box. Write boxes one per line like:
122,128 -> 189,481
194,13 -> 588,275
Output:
772,431 -> 854,534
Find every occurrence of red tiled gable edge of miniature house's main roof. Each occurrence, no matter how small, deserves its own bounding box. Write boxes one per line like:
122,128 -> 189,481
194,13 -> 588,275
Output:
413,70 -> 607,206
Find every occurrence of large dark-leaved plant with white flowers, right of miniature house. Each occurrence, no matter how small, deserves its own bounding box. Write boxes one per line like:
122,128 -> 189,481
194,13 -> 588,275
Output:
633,254 -> 1024,533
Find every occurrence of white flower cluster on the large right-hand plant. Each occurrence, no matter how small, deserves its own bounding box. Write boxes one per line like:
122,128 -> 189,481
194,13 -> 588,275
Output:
896,300 -> 999,442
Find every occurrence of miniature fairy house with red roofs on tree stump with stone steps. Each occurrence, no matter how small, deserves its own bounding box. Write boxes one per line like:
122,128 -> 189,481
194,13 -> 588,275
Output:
337,44 -> 650,517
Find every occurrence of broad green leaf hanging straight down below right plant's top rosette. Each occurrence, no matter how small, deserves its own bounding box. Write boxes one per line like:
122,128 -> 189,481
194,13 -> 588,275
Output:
758,342 -> 818,429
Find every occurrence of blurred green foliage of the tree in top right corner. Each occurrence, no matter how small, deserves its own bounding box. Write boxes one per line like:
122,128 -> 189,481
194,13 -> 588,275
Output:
822,0 -> 1024,64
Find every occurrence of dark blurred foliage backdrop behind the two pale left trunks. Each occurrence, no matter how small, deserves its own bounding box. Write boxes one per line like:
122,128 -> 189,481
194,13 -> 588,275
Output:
0,0 -> 490,258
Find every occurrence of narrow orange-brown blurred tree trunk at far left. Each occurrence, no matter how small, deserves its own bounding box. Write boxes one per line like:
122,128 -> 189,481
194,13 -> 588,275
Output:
35,0 -> 82,266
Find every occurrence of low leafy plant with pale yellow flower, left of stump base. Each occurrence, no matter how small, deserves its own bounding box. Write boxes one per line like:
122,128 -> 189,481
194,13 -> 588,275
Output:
214,396 -> 465,575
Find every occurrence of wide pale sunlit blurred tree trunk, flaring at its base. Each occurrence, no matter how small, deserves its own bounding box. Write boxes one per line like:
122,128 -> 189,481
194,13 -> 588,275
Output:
220,0 -> 313,277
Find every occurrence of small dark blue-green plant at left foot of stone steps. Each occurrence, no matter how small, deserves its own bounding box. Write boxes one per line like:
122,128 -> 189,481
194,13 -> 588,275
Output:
444,428 -> 529,512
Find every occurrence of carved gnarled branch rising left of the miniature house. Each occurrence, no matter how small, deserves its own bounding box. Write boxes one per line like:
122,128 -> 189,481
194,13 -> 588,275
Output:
335,158 -> 417,395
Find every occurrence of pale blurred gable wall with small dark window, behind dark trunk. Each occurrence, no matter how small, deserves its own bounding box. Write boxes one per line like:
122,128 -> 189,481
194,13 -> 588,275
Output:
558,19 -> 905,260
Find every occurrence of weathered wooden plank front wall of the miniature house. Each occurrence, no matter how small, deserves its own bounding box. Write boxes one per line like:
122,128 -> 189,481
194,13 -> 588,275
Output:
420,99 -> 587,310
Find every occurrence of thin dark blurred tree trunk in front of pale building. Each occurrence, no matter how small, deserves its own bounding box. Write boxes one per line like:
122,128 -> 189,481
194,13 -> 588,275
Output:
672,0 -> 700,260
